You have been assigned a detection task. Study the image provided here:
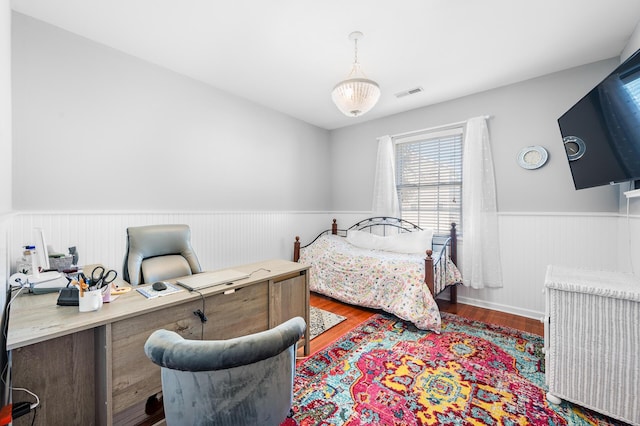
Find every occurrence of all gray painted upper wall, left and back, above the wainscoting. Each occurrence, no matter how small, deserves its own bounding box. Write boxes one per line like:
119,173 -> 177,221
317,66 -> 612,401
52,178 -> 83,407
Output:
10,13 -> 632,218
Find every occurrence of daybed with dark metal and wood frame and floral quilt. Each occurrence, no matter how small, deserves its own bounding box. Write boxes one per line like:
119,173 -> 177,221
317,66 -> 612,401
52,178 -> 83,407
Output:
293,217 -> 462,332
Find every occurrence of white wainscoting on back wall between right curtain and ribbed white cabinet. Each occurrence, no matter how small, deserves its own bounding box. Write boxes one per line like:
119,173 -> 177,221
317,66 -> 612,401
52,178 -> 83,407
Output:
458,213 -> 628,318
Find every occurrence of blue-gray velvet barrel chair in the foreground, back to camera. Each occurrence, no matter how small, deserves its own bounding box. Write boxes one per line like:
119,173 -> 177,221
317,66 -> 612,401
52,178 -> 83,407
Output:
144,317 -> 306,426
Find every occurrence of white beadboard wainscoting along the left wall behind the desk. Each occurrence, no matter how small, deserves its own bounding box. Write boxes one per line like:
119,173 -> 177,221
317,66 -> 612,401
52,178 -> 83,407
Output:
9,212 -> 340,271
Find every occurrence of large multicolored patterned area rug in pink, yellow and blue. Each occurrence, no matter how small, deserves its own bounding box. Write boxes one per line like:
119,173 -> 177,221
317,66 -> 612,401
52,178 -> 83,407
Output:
285,313 -> 616,426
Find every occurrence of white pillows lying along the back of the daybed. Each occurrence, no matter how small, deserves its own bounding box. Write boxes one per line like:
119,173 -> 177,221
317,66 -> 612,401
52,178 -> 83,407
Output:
347,229 -> 433,254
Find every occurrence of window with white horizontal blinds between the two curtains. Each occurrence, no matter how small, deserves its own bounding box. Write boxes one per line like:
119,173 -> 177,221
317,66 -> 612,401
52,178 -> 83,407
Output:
394,127 -> 463,234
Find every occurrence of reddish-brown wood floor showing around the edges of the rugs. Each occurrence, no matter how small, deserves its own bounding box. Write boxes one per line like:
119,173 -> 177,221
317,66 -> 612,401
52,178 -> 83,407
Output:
299,293 -> 544,358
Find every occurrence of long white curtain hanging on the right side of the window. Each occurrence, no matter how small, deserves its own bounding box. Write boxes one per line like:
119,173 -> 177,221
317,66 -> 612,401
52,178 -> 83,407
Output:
462,117 -> 502,288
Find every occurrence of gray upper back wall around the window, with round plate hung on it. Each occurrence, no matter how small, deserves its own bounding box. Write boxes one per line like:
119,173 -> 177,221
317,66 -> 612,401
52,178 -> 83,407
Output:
331,58 -> 619,212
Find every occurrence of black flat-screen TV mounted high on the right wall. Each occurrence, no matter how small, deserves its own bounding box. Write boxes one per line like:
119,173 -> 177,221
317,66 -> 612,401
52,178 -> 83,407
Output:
558,50 -> 640,189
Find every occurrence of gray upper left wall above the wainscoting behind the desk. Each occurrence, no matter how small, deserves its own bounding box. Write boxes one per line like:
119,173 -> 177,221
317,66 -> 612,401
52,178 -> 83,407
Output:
11,13 -> 330,211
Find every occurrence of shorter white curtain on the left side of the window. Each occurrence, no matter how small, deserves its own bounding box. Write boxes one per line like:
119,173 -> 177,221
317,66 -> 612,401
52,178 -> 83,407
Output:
371,136 -> 400,217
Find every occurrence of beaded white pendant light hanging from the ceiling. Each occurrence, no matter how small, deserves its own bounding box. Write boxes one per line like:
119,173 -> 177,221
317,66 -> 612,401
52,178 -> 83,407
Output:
331,31 -> 380,117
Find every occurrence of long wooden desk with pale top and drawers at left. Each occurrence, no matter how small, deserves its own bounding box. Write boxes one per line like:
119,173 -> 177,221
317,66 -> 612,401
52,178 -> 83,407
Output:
7,260 -> 310,426
